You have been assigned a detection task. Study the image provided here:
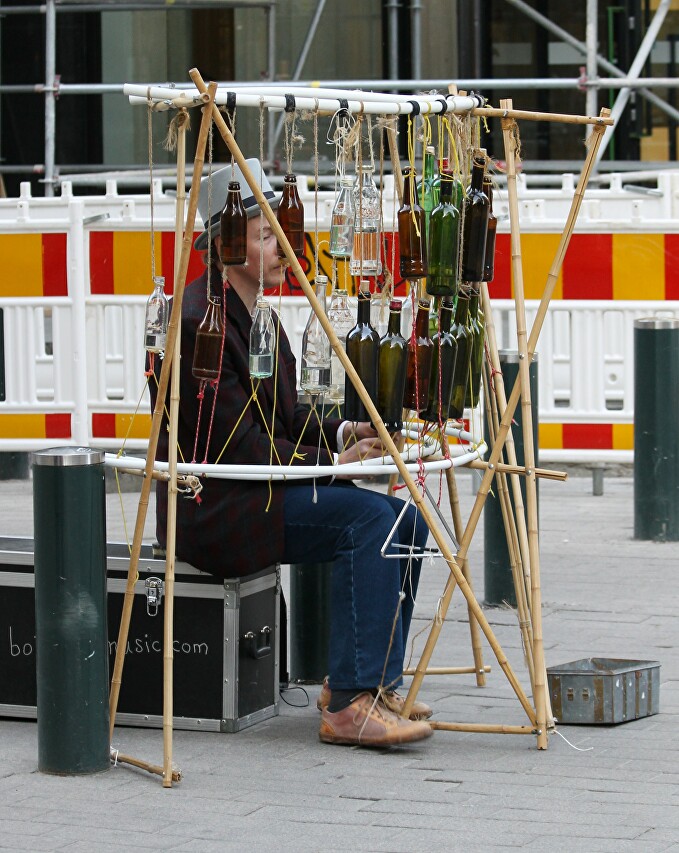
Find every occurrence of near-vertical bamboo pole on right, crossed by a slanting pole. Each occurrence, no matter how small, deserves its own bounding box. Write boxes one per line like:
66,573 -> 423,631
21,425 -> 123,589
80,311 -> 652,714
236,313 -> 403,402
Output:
500,98 -> 553,749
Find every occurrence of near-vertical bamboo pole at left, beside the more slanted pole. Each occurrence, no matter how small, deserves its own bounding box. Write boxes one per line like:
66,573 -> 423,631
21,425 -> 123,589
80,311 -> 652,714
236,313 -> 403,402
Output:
163,110 -> 188,788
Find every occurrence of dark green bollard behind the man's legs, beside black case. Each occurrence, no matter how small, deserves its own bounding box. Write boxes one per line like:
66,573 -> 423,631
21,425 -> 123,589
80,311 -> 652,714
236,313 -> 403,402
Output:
289,563 -> 333,684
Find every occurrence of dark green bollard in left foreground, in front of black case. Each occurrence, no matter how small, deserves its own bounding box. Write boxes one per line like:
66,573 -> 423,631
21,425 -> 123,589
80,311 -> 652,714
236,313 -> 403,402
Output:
33,447 -> 110,775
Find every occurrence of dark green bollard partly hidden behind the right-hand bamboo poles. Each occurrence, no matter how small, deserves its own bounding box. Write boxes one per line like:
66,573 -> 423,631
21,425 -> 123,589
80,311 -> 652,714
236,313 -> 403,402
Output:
483,350 -> 538,607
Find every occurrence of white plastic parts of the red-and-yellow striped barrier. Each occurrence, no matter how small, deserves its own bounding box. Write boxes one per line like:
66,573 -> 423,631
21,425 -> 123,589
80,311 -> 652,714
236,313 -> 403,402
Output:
0,173 -> 679,458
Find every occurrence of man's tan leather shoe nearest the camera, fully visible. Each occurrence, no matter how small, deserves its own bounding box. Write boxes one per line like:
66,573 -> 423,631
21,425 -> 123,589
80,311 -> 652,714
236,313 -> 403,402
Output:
318,690 -> 432,747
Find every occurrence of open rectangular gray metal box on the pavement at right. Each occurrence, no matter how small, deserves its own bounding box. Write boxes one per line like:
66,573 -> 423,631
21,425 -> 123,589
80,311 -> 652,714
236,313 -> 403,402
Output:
547,658 -> 660,725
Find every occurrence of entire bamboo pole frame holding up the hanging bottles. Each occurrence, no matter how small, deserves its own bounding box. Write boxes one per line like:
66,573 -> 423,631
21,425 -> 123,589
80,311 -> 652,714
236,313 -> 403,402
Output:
110,69 -> 610,787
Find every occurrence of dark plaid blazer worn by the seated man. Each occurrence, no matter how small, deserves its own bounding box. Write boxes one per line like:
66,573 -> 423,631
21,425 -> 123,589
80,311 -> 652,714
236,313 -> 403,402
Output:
151,270 -> 340,577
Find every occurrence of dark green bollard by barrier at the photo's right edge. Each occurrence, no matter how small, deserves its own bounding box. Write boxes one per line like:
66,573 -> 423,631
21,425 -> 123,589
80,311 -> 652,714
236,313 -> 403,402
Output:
634,317 -> 679,542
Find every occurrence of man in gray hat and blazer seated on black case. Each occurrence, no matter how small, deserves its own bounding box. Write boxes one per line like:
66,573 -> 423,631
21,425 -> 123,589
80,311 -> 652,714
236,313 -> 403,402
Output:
151,160 -> 432,747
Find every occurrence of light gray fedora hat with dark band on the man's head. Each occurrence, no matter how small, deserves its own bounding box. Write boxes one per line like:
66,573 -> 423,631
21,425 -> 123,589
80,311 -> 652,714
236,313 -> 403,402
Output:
193,157 -> 279,251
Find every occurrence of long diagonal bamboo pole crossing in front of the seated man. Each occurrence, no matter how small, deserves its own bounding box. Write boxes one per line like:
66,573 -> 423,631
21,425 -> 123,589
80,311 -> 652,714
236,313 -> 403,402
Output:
189,68 -> 535,723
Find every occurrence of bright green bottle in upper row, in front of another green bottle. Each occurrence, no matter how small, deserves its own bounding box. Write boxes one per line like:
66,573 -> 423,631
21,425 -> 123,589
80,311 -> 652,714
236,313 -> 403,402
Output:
426,172 -> 460,298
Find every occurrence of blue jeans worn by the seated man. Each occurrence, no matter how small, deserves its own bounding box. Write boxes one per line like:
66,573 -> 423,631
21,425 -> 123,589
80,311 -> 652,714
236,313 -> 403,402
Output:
283,480 -> 429,690
